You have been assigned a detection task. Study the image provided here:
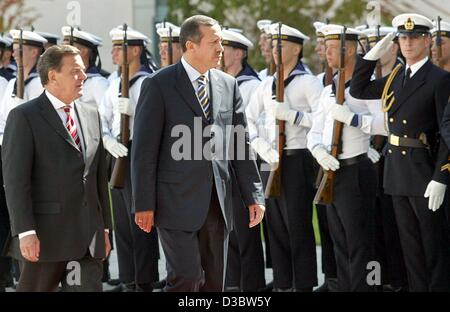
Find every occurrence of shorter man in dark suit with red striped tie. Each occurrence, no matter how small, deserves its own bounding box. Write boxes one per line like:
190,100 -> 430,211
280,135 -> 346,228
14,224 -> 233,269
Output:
2,46 -> 111,291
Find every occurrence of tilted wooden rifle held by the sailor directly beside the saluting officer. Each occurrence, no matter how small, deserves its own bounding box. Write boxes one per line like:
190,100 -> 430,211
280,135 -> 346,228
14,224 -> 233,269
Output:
314,26 -> 347,205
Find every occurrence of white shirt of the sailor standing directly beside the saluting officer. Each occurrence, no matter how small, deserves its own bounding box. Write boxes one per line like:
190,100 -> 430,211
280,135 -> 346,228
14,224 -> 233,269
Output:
308,85 -> 387,159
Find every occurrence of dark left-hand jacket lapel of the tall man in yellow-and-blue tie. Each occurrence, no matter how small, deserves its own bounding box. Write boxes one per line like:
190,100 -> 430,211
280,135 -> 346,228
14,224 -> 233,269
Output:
175,61 -> 209,124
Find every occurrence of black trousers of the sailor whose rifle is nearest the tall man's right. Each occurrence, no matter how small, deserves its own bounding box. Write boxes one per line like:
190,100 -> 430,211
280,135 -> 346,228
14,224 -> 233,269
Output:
262,149 -> 317,290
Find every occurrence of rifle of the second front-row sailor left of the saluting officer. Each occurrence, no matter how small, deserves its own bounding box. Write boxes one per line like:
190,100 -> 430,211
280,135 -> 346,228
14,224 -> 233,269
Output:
265,22 -> 286,198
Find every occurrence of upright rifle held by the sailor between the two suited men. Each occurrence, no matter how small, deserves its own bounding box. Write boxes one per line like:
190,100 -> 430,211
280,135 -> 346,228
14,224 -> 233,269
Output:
109,24 -> 130,188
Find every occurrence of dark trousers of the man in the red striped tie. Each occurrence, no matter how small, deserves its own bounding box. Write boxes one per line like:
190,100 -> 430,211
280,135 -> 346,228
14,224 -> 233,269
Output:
17,255 -> 103,292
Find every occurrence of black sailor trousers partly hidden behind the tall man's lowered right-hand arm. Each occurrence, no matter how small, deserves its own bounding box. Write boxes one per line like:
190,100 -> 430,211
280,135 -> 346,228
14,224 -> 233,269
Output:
225,174 -> 265,291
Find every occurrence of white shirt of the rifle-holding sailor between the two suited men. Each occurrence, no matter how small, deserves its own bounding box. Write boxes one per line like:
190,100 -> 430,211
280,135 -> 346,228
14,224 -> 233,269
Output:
98,72 -> 150,140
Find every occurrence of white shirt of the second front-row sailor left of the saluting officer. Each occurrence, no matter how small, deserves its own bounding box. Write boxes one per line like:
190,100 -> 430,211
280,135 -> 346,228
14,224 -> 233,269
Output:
246,70 -> 323,149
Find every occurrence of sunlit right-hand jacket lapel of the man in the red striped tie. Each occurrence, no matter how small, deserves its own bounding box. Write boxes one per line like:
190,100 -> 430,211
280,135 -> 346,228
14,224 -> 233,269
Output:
75,102 -> 100,173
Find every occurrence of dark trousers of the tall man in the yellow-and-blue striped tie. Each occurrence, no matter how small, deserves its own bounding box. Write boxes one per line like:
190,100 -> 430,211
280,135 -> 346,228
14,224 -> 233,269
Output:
158,187 -> 228,292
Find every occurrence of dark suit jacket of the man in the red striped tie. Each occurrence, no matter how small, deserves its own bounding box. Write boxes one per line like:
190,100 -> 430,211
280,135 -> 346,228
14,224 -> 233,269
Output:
2,93 -> 111,262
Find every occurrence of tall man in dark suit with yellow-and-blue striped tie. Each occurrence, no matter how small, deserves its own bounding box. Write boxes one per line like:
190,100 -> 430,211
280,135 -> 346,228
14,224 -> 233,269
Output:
131,15 -> 264,291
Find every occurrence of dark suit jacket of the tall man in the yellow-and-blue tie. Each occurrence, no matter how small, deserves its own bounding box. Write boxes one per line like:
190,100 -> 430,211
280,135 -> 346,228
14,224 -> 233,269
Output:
131,62 -> 264,231
